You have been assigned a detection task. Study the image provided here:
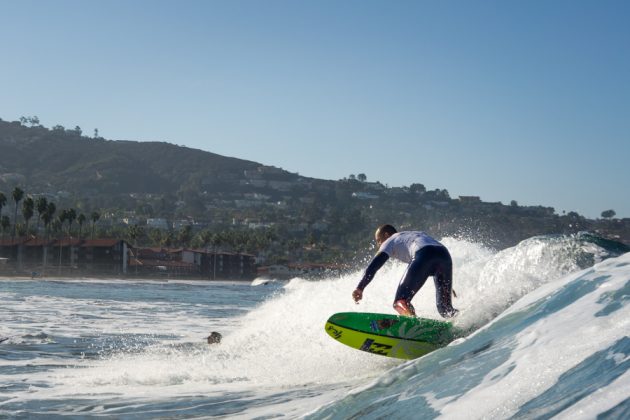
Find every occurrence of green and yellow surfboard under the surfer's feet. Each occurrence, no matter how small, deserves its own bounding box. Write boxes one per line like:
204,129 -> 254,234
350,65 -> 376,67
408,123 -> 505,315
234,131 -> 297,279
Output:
325,312 -> 456,359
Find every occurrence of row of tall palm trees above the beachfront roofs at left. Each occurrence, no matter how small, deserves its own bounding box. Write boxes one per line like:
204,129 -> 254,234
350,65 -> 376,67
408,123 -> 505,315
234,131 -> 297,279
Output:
0,187 -> 101,240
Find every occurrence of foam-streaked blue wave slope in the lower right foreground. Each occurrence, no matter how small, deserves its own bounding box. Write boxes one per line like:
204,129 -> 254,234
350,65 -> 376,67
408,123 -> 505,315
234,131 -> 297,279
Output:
307,254 -> 630,419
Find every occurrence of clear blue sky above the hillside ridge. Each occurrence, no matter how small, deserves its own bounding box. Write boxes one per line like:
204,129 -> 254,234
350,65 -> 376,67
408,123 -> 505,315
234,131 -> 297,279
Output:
0,0 -> 630,217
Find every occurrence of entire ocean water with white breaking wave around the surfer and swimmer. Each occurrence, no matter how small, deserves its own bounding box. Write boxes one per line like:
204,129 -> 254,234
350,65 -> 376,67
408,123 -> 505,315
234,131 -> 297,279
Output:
0,235 -> 630,419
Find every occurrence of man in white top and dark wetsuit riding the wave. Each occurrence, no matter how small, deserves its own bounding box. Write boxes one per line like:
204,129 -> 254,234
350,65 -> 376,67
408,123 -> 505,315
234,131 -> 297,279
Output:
352,225 -> 459,318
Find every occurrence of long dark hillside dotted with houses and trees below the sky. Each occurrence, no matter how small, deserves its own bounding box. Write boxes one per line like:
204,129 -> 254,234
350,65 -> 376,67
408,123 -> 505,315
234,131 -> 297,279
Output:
0,120 -> 630,262
